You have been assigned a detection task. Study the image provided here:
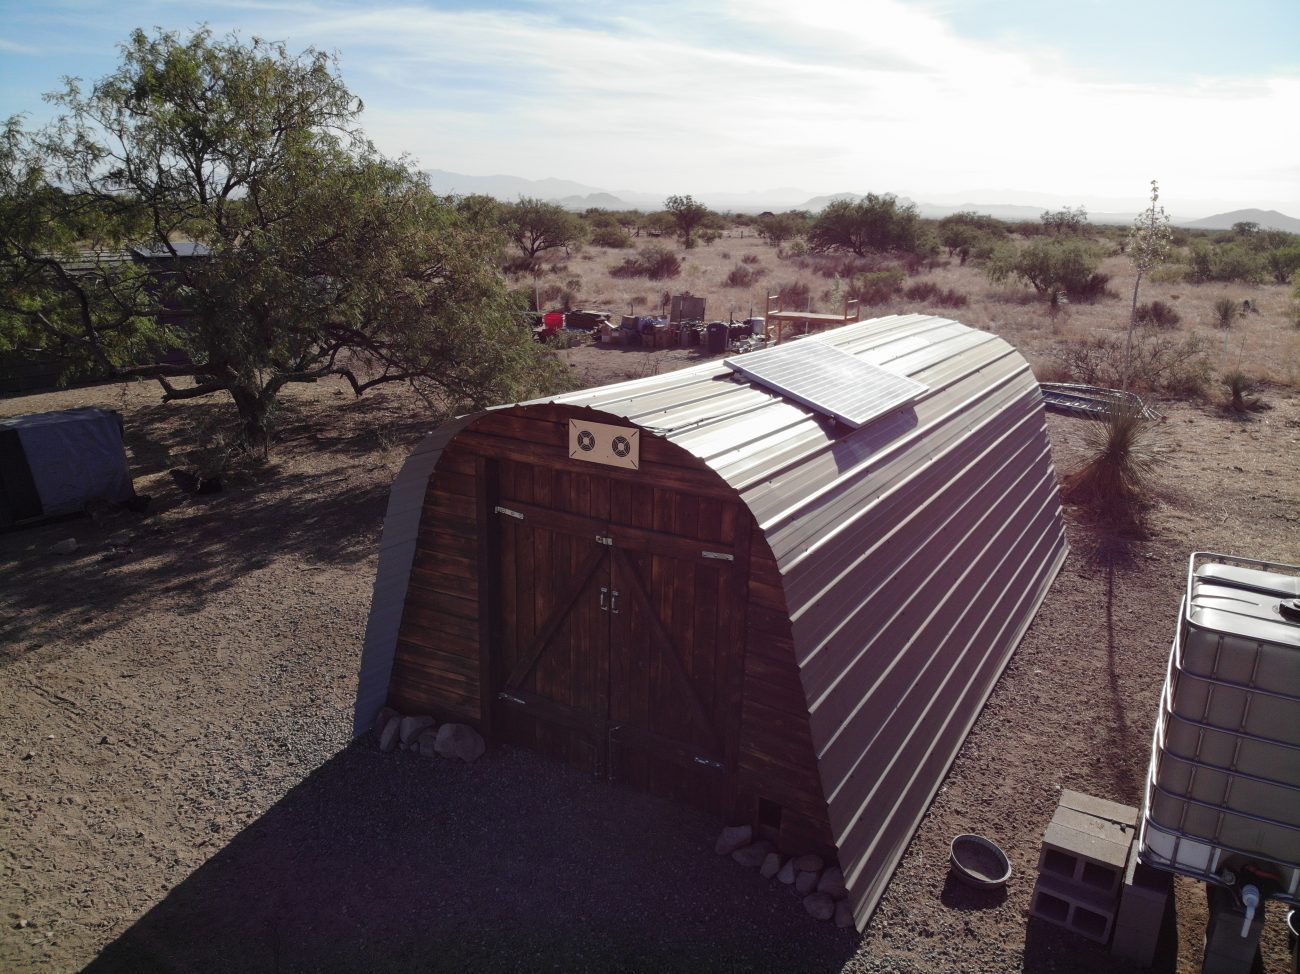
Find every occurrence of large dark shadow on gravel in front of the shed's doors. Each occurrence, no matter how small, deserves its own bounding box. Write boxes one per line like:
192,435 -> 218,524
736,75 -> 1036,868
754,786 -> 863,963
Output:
85,737 -> 858,974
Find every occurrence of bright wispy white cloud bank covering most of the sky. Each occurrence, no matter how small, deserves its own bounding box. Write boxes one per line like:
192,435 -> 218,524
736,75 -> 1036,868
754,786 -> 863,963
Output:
7,0 -> 1300,208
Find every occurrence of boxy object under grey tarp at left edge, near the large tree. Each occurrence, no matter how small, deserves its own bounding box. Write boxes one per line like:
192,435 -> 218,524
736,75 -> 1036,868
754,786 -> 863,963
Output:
0,406 -> 135,527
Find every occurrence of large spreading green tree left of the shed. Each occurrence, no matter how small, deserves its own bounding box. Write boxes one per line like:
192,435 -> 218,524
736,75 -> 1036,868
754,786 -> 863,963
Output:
0,30 -> 554,454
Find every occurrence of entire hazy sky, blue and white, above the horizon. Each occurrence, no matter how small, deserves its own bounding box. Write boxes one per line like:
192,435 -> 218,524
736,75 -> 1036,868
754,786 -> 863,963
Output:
0,0 -> 1300,218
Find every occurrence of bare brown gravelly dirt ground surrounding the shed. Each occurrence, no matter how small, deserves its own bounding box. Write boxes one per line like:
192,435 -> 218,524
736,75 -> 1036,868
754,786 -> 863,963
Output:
0,332 -> 1300,973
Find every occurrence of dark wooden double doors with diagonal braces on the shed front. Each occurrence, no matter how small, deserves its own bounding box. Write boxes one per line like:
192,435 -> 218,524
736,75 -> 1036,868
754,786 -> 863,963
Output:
491,462 -> 748,808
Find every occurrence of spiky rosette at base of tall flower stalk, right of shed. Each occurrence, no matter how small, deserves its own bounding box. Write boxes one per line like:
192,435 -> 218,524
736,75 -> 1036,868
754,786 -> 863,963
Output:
1065,401 -> 1160,528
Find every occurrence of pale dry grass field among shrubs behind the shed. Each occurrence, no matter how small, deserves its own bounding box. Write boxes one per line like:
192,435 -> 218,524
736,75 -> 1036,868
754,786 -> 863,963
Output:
527,229 -> 1300,388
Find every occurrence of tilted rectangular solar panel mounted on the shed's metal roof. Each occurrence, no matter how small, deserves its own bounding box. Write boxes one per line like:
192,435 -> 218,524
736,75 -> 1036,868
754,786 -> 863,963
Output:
727,338 -> 928,427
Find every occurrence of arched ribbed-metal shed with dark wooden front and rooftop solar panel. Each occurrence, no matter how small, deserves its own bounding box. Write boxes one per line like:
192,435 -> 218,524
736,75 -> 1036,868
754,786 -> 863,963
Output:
356,315 -> 1066,927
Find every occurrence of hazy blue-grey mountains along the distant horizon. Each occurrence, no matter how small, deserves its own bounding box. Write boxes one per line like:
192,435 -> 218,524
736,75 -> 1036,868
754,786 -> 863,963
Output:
425,169 -> 1300,233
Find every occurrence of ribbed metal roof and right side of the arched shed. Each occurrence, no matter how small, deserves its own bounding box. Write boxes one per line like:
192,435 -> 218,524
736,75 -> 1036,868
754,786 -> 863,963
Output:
358,315 -> 1066,927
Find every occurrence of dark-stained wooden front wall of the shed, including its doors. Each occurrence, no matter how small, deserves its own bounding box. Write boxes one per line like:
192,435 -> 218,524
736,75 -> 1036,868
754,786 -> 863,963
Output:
389,406 -> 833,853
